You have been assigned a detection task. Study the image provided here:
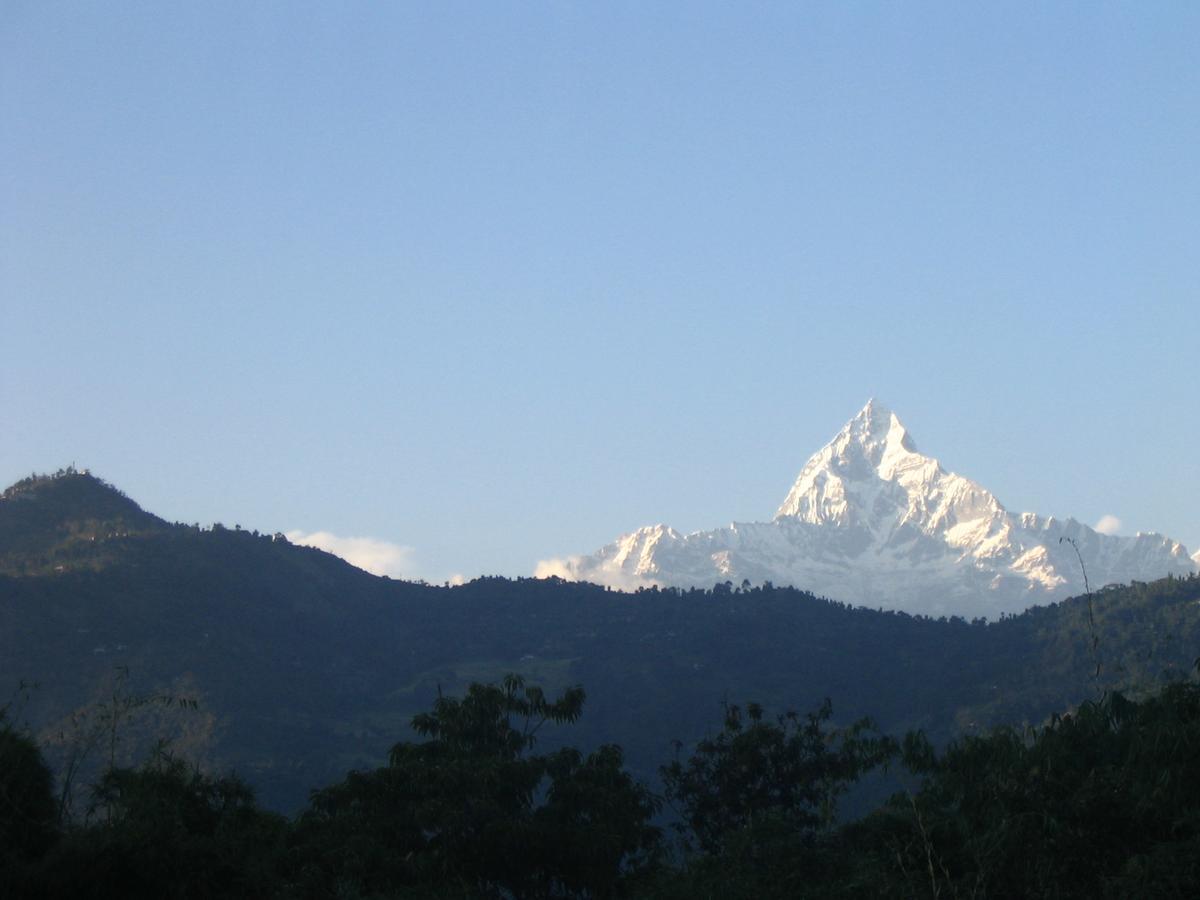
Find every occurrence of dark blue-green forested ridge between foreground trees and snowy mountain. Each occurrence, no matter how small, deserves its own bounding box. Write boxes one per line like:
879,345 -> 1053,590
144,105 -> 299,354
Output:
7,472 -> 1200,810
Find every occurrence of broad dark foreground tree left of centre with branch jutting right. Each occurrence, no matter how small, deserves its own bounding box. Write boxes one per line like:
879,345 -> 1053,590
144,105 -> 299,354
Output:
295,676 -> 659,898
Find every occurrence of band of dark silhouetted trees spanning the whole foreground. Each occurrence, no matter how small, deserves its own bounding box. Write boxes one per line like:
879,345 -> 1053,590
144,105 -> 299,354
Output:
7,676 -> 1200,900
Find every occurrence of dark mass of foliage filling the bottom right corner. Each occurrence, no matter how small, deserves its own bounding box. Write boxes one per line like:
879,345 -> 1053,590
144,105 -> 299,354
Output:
859,684 -> 1200,898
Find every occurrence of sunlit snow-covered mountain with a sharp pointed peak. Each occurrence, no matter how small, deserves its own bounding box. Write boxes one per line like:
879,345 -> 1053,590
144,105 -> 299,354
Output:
538,400 -> 1200,618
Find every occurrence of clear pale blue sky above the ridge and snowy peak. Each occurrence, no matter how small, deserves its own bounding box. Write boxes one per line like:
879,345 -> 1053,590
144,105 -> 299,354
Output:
0,0 -> 1200,581
